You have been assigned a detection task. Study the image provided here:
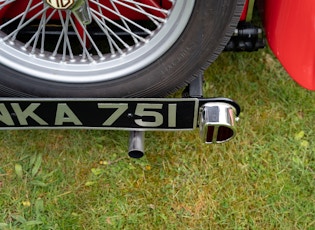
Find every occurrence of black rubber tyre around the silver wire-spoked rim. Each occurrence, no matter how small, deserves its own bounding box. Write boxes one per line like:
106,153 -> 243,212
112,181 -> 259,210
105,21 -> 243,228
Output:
0,0 -> 244,97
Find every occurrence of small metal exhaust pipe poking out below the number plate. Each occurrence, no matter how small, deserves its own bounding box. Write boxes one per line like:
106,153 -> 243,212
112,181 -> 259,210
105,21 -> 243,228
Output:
128,131 -> 144,158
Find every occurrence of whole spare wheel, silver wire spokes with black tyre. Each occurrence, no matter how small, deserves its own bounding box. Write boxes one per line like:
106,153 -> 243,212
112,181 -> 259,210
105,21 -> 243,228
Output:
0,0 -> 244,97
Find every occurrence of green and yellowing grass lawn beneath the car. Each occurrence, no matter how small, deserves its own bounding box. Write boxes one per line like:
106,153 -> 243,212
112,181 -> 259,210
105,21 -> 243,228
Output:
0,49 -> 315,230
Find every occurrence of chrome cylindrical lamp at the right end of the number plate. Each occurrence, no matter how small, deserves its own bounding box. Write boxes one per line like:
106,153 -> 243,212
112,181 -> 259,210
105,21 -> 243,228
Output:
199,102 -> 236,144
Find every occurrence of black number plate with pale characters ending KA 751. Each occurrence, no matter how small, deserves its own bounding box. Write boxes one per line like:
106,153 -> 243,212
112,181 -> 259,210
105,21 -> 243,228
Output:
0,98 -> 199,130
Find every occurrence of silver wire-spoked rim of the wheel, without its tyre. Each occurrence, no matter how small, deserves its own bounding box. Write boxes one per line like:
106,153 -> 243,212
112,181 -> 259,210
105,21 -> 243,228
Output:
0,0 -> 194,83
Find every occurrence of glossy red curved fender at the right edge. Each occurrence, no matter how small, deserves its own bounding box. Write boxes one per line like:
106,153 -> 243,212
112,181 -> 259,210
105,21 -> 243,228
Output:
264,0 -> 315,90
